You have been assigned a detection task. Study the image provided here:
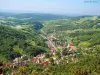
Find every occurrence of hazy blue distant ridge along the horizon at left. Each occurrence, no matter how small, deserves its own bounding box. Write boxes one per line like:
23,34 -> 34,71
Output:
0,12 -> 67,21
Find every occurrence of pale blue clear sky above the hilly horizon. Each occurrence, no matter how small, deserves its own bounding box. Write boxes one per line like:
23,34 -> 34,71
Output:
0,0 -> 100,15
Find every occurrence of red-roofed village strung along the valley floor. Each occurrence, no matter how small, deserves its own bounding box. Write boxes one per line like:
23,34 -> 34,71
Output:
8,30 -> 78,68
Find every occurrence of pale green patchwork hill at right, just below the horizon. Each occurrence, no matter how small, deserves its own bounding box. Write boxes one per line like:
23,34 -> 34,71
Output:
44,16 -> 100,31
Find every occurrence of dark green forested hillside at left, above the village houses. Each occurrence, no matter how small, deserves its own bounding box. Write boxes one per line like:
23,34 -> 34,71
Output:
0,26 -> 46,59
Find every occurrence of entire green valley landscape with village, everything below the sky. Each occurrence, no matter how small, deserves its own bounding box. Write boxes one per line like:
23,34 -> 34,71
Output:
0,13 -> 100,75
